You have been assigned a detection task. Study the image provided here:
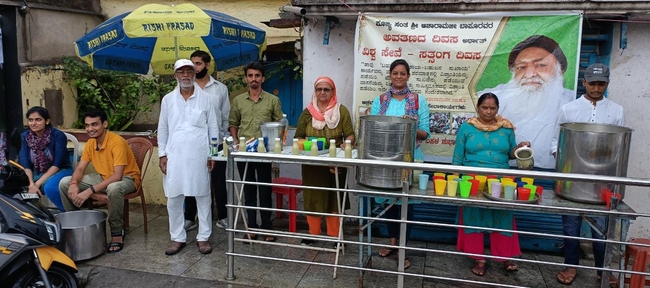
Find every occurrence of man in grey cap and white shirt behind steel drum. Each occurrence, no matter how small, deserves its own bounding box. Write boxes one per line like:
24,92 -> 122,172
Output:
551,63 -> 625,285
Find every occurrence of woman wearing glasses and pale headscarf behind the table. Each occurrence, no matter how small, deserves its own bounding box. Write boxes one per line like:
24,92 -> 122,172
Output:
295,76 -> 354,247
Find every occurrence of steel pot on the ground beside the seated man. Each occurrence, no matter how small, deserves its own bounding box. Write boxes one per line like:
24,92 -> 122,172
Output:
54,210 -> 106,261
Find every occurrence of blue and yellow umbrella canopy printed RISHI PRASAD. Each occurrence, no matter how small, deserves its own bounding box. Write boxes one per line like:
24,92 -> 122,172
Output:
75,4 -> 266,74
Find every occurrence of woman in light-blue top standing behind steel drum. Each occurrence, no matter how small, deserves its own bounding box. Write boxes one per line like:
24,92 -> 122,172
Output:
370,59 -> 429,269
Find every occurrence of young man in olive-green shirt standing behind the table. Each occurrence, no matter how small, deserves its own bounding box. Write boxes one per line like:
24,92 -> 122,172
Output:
228,62 -> 282,242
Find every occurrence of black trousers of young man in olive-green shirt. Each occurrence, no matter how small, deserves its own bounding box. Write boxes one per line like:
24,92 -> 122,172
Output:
237,162 -> 273,229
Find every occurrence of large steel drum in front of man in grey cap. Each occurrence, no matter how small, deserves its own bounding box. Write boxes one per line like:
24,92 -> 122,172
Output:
555,123 -> 632,204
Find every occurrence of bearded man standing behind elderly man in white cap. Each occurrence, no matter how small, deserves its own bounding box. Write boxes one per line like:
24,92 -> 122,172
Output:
184,50 -> 230,230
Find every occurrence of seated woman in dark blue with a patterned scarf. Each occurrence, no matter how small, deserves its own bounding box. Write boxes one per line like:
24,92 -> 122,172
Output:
18,106 -> 73,211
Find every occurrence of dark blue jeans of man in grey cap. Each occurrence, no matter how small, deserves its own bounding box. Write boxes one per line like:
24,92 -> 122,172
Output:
562,215 -> 606,275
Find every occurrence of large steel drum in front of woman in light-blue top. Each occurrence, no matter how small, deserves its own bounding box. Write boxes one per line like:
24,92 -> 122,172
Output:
356,115 -> 417,189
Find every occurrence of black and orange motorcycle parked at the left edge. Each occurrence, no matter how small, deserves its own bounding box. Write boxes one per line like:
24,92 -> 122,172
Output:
0,156 -> 79,288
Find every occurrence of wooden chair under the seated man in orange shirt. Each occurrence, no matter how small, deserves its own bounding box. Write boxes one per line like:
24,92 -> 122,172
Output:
90,137 -> 153,234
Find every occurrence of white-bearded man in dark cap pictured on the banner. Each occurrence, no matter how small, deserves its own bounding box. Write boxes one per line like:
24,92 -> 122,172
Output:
478,35 -> 575,169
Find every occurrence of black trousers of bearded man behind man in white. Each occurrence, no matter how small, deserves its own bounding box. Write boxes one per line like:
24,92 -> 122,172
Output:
185,161 -> 228,221
